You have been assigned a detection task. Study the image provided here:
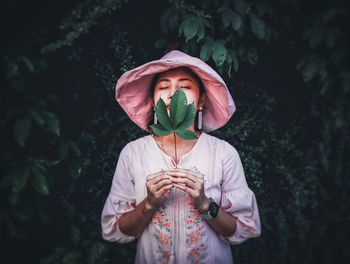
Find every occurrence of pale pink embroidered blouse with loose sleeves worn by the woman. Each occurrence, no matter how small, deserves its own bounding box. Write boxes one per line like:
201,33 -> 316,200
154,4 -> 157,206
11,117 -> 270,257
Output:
101,133 -> 261,264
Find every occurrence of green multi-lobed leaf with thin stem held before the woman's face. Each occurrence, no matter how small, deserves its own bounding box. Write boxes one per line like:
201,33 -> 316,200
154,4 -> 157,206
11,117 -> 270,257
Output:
150,89 -> 197,162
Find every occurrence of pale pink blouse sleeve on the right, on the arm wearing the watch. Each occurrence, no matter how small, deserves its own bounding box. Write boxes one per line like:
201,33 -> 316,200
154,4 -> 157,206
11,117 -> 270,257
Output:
221,142 -> 261,245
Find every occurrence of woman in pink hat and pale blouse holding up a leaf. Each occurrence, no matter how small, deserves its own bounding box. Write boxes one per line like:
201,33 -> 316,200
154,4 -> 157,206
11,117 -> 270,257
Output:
101,50 -> 261,263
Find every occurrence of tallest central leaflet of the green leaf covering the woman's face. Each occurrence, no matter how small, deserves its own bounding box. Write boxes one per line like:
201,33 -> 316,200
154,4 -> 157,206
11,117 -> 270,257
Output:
170,89 -> 187,129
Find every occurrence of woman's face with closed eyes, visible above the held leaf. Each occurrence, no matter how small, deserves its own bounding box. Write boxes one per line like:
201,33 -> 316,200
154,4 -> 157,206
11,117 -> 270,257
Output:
153,68 -> 204,110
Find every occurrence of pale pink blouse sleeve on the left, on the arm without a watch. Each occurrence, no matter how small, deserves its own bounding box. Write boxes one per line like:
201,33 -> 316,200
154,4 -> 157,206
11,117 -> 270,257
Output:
101,145 -> 136,243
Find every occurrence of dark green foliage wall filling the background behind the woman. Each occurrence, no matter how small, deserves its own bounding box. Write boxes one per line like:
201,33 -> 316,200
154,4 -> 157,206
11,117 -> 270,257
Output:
0,0 -> 350,264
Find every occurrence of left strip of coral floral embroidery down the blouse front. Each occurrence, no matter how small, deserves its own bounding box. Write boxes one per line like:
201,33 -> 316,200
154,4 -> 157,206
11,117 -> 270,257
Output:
152,203 -> 173,263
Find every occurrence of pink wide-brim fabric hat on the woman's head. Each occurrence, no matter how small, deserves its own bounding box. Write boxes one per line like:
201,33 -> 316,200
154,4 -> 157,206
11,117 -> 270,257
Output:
115,50 -> 236,132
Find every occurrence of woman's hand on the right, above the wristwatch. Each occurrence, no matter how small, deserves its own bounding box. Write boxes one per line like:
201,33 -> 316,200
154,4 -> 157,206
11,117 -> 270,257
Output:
167,168 -> 210,212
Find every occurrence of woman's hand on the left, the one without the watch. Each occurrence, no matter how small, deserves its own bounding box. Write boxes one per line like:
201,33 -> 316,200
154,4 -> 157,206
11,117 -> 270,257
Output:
145,171 -> 173,211
